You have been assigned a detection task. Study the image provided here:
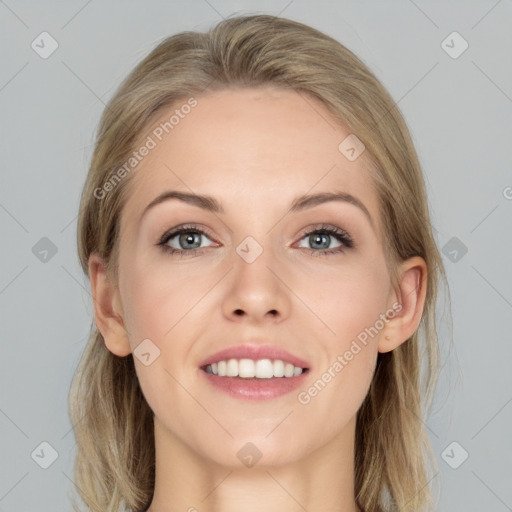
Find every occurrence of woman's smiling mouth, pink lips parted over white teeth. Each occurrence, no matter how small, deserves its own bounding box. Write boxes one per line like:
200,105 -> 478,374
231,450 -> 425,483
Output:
199,345 -> 310,400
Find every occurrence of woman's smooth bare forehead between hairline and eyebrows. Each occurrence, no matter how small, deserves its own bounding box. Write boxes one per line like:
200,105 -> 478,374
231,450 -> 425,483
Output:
120,87 -> 378,226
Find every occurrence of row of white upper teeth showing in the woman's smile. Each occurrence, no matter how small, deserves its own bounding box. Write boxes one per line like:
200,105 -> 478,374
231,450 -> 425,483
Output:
206,359 -> 303,379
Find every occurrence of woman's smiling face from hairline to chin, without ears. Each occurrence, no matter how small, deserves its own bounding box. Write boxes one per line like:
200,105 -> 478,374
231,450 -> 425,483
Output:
111,88 -> 394,466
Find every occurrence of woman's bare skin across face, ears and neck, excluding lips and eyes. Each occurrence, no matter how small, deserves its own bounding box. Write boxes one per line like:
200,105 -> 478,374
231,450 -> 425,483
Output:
89,87 -> 426,512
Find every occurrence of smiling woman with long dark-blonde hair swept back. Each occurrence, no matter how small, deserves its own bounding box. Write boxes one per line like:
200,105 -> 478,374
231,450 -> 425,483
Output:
70,15 -> 444,512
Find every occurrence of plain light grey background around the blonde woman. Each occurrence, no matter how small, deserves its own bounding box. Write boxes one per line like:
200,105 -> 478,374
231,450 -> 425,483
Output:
0,0 -> 512,512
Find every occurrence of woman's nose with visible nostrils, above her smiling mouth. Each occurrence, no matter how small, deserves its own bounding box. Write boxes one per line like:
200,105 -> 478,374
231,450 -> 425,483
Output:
222,244 -> 291,323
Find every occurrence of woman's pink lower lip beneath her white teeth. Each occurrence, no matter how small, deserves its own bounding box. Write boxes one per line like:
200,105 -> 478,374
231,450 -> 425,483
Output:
201,370 -> 308,400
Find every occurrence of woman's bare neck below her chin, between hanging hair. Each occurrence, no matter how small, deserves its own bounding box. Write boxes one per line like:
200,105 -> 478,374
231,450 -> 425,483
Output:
147,418 -> 358,512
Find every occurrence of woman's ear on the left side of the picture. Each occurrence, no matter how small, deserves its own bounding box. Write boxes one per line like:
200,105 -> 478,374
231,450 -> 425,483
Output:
88,253 -> 131,357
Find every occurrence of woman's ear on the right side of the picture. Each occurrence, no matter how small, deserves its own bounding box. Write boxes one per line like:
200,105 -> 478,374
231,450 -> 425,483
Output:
378,256 -> 427,352
